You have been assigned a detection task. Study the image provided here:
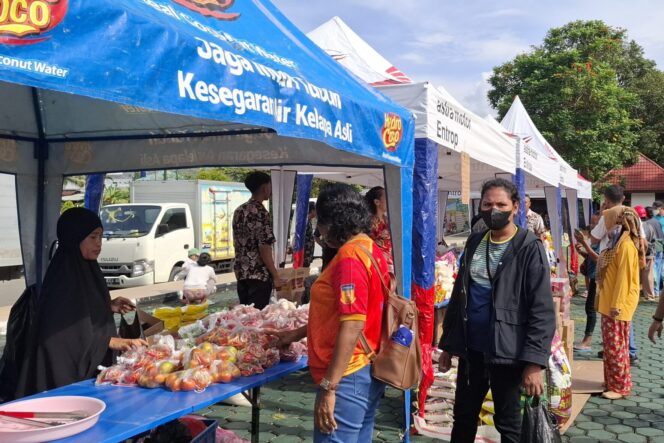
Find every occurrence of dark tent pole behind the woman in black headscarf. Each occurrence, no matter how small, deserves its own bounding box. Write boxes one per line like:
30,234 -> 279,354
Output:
32,88 -> 48,289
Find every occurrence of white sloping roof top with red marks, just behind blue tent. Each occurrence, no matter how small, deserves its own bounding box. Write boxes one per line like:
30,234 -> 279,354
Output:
307,17 -> 411,86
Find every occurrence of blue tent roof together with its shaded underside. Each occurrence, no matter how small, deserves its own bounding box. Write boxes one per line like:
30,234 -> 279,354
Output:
0,0 -> 413,169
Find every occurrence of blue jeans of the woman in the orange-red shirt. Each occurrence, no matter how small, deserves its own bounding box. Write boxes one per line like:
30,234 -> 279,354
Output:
314,365 -> 385,443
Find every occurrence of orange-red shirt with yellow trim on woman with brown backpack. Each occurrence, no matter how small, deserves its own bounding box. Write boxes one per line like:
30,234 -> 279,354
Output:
307,234 -> 389,384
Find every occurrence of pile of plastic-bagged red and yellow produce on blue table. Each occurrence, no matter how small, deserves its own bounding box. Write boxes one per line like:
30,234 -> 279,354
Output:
97,300 -> 309,391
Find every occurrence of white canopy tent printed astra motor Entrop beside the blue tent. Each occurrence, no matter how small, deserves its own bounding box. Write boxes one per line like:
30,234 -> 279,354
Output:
307,17 -> 516,243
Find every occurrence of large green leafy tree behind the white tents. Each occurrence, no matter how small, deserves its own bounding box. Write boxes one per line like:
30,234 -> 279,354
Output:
488,21 -> 656,180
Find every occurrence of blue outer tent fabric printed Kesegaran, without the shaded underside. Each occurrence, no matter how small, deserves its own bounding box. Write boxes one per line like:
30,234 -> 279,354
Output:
0,0 -> 414,166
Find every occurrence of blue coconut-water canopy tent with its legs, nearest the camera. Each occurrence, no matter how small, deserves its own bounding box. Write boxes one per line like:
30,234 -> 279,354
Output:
0,0 -> 414,435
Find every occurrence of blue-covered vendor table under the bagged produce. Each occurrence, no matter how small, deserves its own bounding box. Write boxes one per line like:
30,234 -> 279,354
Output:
22,358 -> 313,443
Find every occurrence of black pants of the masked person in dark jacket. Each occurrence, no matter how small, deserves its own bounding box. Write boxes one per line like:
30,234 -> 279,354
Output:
451,350 -> 523,443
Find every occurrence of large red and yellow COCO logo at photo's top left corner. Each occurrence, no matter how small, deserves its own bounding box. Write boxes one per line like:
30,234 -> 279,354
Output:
0,0 -> 67,45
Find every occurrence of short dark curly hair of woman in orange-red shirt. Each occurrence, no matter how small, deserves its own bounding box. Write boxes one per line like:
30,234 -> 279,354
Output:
316,183 -> 372,245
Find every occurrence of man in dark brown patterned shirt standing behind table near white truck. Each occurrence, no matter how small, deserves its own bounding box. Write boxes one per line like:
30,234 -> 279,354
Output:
233,172 -> 283,309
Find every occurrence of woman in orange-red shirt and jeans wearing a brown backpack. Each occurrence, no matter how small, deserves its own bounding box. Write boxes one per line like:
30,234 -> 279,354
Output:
278,184 -> 389,443
